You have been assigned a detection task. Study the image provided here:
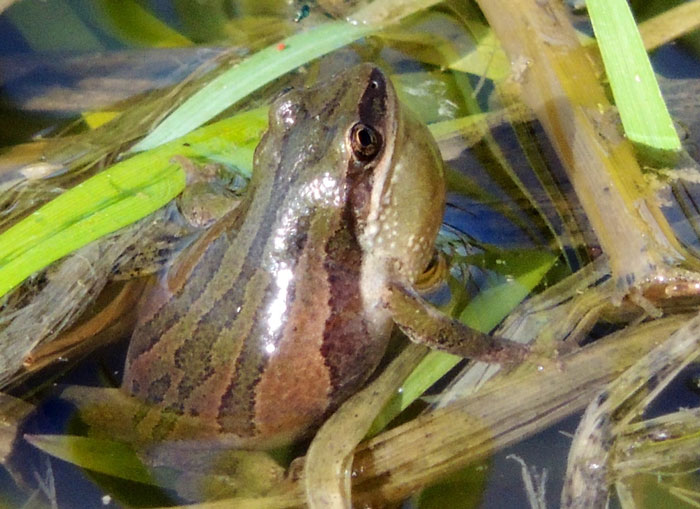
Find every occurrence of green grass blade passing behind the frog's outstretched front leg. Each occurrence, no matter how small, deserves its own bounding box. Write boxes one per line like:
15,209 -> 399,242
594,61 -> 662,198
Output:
367,250 -> 557,436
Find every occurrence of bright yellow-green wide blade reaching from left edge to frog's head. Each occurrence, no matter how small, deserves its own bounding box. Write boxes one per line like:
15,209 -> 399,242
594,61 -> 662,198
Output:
0,108 -> 267,297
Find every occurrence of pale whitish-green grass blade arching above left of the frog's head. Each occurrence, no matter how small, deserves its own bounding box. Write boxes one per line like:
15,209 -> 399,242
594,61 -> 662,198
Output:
132,22 -> 375,152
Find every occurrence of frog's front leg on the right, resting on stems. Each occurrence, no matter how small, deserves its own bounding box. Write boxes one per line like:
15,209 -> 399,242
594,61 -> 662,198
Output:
384,281 -> 530,364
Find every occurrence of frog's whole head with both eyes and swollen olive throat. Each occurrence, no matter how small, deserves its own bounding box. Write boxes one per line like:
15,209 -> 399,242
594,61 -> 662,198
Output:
254,64 -> 445,282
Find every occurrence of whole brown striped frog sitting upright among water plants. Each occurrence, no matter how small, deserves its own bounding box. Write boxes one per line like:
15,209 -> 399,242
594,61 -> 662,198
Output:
122,65 -> 524,447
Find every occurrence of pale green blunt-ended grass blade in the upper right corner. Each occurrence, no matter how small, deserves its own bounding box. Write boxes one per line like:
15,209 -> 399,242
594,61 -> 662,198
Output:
586,0 -> 681,151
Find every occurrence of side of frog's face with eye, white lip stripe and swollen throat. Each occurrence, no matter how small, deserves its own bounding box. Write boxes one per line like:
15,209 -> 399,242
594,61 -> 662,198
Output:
346,66 -> 445,282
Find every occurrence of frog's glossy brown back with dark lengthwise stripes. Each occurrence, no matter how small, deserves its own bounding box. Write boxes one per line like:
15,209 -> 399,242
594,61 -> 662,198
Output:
123,64 -> 391,442
